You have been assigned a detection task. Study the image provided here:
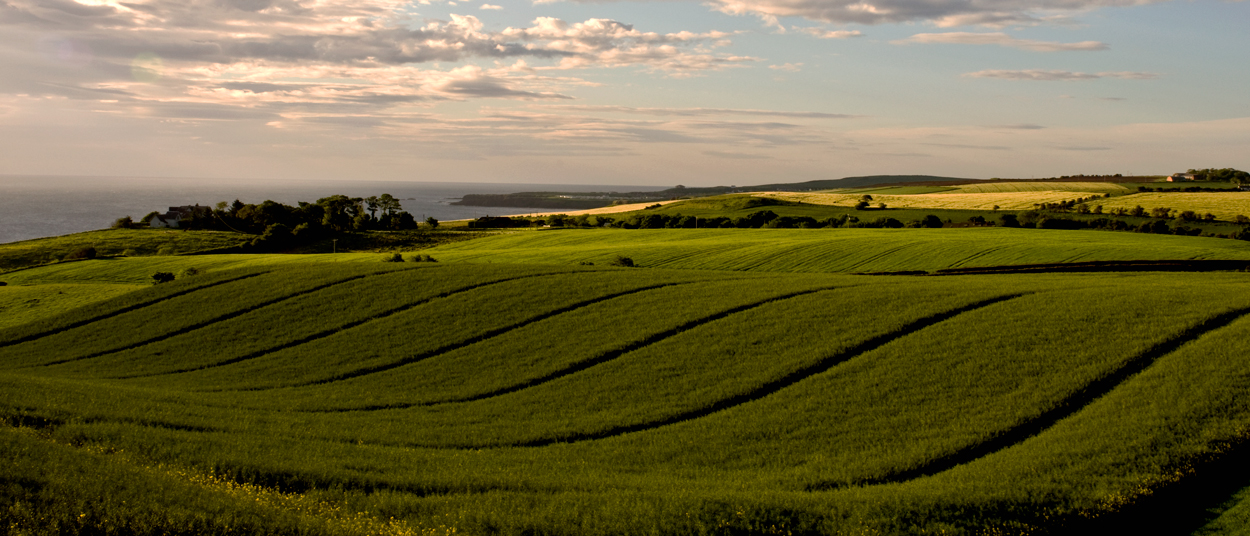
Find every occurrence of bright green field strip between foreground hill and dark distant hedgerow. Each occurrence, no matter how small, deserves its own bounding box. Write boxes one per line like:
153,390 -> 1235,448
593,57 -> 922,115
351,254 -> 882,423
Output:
415,227 -> 1250,272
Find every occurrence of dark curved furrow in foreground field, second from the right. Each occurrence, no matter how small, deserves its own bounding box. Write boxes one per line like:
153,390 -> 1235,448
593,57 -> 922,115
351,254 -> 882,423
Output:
405,289 -> 1025,450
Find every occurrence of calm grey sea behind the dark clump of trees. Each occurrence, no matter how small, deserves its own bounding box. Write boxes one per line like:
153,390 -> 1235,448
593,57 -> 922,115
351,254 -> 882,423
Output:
0,175 -> 668,244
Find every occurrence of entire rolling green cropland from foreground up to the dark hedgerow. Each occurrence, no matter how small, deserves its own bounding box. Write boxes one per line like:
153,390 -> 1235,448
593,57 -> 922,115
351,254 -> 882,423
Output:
0,223 -> 1250,536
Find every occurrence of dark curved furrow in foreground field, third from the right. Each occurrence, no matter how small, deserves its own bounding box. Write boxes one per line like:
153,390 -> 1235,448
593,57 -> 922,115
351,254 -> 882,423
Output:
304,286 -> 845,414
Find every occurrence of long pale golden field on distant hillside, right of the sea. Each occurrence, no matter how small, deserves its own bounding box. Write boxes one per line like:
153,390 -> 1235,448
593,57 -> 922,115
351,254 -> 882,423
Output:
756,190 -> 1110,210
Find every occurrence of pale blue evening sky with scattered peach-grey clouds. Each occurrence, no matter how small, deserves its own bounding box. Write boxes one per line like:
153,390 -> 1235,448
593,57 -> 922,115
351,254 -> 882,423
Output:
0,0 -> 1250,186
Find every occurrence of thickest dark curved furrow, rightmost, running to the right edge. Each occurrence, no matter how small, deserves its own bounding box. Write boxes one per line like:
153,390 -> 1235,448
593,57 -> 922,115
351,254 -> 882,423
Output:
808,302 -> 1250,491
